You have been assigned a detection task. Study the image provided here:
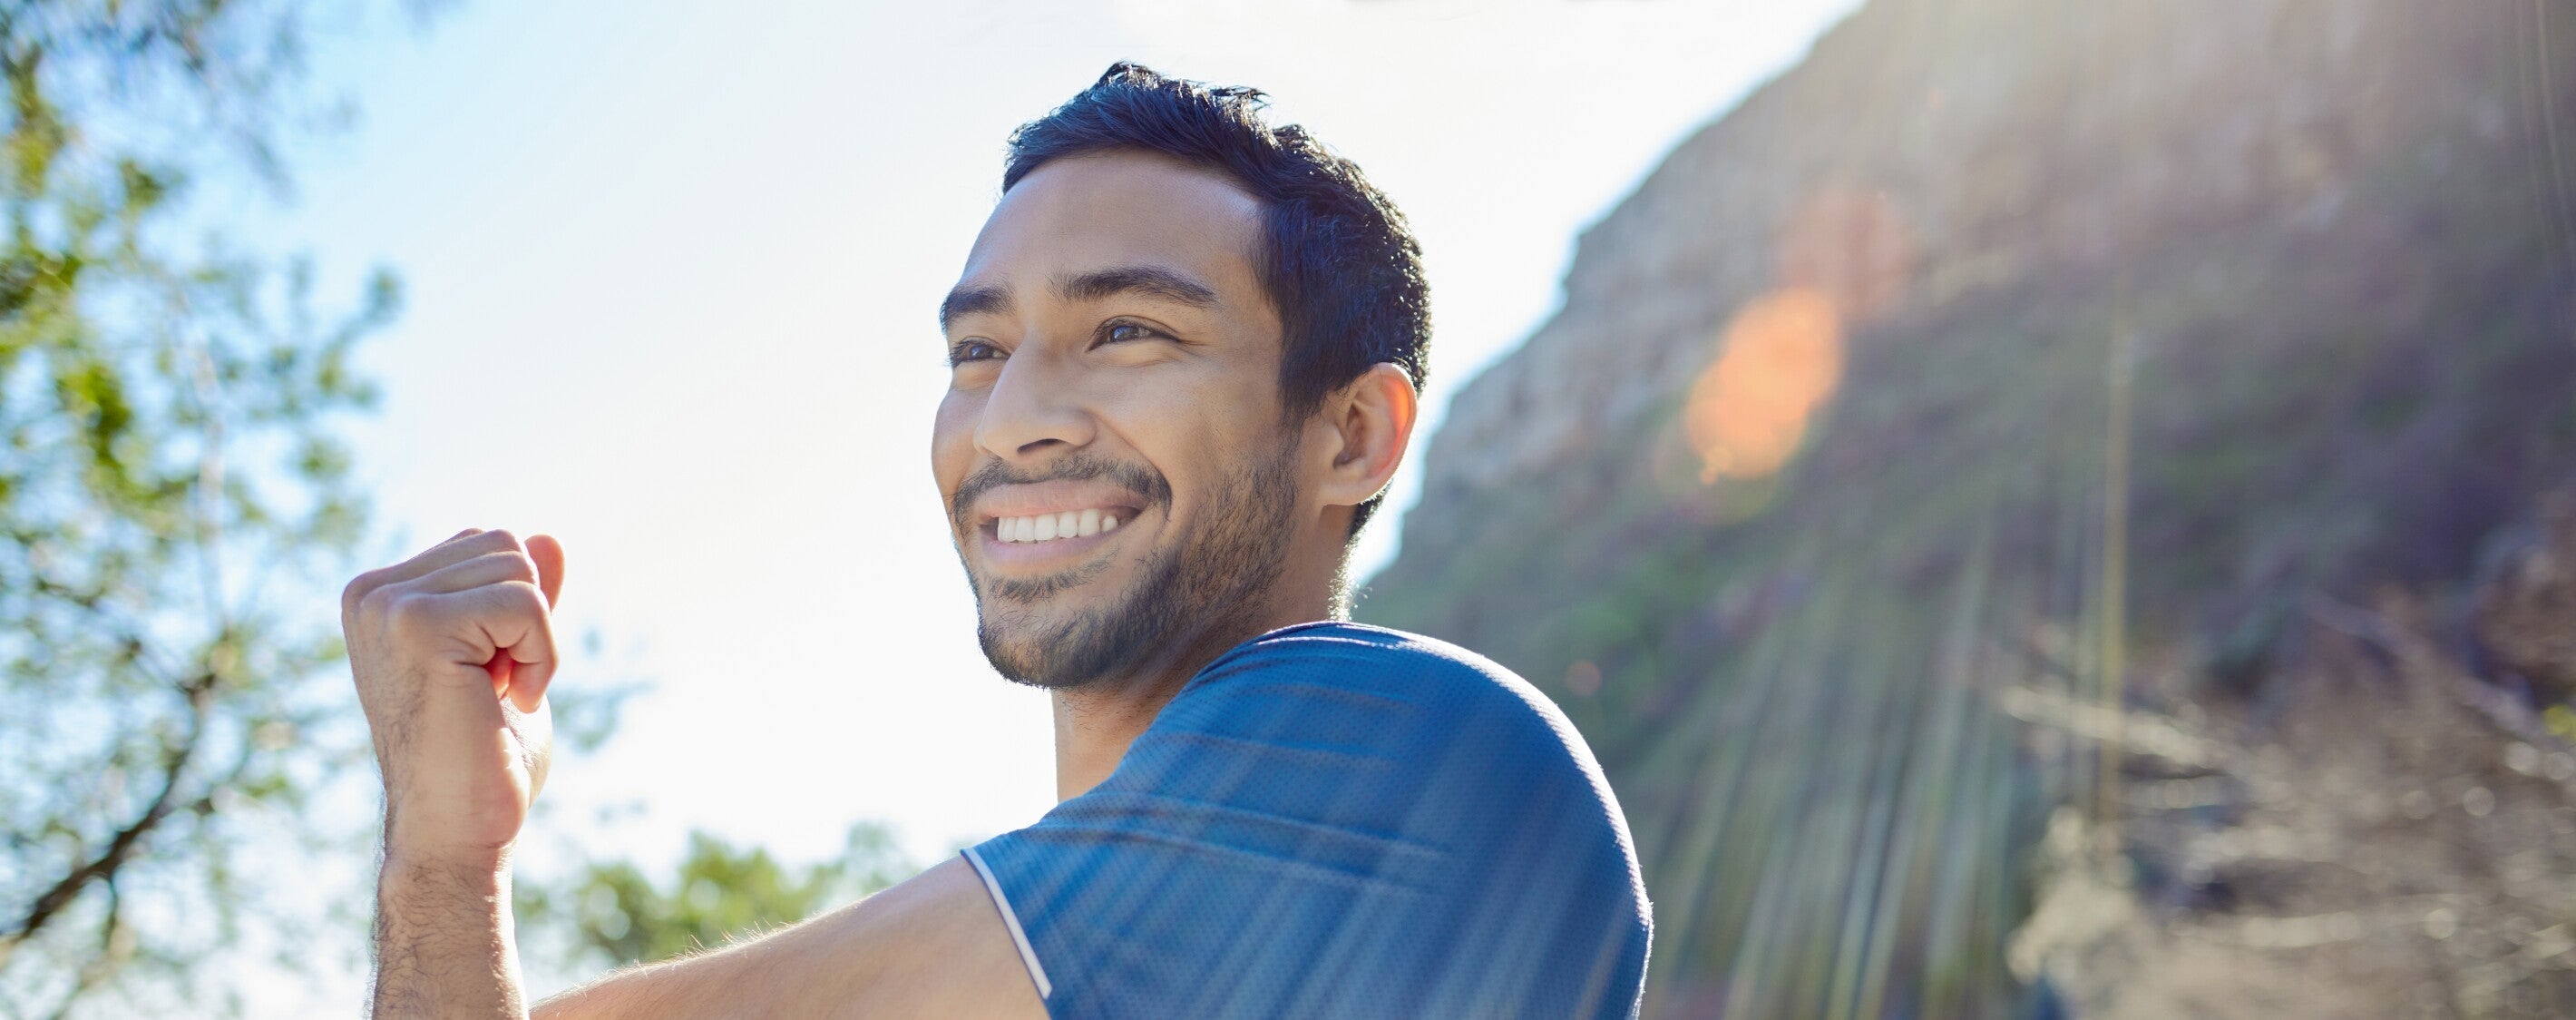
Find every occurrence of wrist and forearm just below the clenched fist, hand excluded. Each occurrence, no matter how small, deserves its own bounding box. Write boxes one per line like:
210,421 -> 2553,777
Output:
374,853 -> 528,1020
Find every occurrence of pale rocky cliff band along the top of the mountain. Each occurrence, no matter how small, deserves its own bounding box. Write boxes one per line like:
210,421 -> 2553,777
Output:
1407,0 -> 2544,525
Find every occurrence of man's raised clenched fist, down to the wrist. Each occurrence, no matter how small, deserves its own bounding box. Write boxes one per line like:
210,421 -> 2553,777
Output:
340,528 -> 564,866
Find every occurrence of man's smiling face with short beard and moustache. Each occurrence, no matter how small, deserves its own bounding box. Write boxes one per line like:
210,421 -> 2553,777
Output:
930,152 -> 1298,688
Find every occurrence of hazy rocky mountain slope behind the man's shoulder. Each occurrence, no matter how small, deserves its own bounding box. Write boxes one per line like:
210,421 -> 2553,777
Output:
1358,0 -> 2576,1017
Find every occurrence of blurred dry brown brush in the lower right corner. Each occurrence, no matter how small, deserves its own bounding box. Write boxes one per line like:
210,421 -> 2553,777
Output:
2012,574 -> 2576,1017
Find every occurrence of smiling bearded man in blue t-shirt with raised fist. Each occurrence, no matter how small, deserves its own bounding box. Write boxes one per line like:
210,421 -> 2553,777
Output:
343,64 -> 1649,1017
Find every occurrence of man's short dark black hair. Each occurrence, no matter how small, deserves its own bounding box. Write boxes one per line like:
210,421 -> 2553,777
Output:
1002,62 -> 1432,535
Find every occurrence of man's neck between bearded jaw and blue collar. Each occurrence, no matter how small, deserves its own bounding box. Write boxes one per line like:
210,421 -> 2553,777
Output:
1049,545 -> 1344,801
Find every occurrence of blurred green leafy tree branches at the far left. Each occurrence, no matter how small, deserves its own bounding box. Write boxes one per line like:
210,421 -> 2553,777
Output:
0,0 -> 422,1015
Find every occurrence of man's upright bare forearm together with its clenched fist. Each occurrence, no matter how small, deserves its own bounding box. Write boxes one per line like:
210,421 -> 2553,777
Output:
340,528 -> 564,1017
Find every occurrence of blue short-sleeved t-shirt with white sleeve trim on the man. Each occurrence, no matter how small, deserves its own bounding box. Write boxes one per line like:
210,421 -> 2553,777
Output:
966,623 -> 1651,1017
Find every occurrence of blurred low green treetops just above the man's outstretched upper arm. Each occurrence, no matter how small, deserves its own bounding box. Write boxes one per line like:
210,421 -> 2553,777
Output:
515,821 -> 920,974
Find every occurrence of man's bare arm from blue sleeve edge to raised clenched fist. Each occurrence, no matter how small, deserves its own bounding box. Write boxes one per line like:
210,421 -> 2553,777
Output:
340,531 -> 1046,1020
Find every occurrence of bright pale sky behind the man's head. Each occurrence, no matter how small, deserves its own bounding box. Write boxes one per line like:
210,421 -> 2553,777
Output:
237,0 -> 1855,999
